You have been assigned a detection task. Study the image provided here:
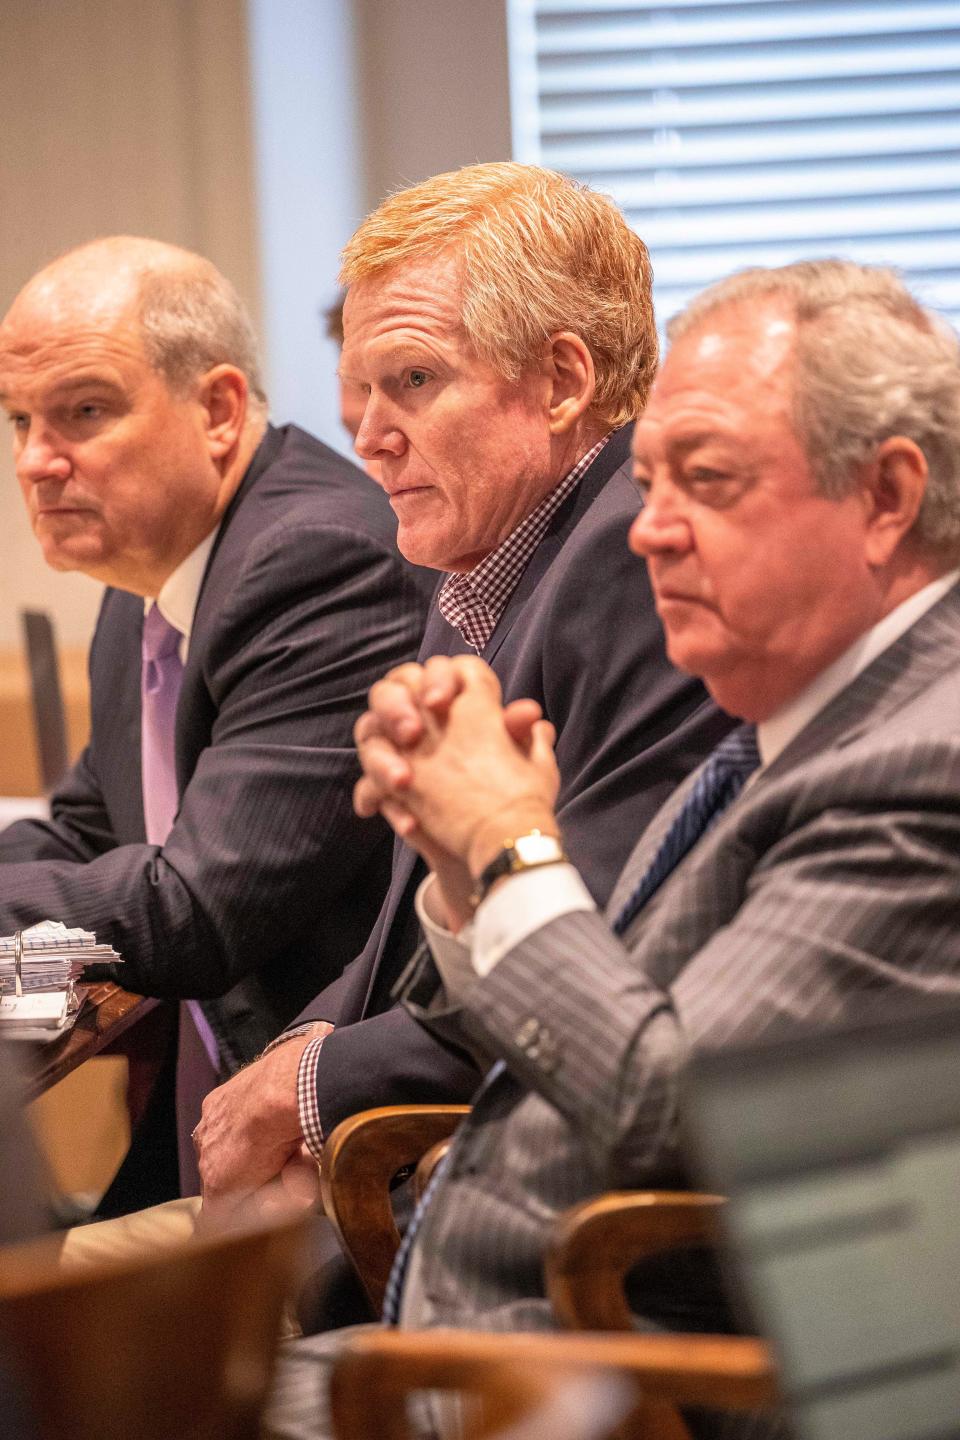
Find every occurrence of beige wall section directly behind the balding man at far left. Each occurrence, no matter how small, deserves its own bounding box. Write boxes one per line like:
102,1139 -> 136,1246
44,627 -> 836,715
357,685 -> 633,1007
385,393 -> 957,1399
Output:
0,0 -> 259,648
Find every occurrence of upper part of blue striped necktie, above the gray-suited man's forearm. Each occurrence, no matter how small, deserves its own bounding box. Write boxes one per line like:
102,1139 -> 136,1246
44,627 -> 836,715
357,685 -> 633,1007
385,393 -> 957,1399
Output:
613,724 -> 760,935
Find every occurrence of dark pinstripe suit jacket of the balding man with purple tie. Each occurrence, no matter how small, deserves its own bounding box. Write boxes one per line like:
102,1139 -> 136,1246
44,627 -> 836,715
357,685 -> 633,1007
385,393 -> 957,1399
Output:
0,426 -> 436,1070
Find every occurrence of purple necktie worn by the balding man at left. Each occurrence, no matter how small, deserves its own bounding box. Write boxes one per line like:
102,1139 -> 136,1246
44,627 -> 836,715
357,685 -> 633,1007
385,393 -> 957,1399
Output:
140,602 -> 220,1195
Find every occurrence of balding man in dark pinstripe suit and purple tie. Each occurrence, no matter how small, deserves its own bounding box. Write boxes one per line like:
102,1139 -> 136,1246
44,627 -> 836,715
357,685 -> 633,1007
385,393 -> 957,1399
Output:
0,236 -> 433,1212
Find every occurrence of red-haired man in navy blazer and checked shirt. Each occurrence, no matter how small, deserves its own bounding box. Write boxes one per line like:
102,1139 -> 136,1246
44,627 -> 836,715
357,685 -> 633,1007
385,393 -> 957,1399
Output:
197,163 -> 730,1238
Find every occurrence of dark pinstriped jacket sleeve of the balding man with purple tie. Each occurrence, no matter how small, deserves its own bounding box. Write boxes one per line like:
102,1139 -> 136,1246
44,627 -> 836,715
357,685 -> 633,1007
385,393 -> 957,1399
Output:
0,518 -> 425,996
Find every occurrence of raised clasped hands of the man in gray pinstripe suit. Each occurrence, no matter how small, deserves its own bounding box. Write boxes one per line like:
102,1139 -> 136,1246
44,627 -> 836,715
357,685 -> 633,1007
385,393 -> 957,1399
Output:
354,655 -> 560,930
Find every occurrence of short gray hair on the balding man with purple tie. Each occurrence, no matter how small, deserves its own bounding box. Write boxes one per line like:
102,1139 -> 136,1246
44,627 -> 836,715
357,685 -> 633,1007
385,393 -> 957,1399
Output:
137,256 -> 268,419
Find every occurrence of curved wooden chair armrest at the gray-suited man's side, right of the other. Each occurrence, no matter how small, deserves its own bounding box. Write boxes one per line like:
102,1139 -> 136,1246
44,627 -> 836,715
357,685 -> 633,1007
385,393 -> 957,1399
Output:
544,1191 -> 724,1331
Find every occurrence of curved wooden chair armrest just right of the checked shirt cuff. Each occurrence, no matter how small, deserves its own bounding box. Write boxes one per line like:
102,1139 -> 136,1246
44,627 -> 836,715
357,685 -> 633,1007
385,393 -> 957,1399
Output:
320,1104 -> 469,1315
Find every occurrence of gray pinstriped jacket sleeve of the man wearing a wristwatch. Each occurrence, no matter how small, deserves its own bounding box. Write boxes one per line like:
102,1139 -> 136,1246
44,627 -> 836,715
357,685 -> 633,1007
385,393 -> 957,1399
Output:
407,742 -> 960,1188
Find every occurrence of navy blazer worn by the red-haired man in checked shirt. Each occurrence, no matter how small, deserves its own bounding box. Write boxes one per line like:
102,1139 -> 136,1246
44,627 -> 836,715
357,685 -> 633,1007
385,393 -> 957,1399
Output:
299,429 -> 733,1133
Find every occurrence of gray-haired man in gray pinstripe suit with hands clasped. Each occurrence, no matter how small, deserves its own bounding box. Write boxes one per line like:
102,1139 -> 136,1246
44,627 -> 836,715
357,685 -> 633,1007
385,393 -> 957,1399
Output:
268,262 -> 960,1440
